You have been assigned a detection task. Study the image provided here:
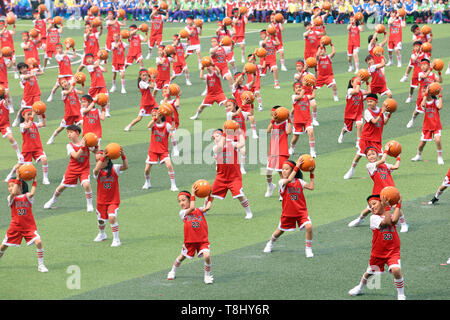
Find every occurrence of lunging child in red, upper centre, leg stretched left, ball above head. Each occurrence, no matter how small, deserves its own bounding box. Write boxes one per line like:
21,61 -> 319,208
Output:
190,64 -> 227,120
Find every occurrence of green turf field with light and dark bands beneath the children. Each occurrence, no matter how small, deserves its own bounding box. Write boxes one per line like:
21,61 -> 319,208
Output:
0,21 -> 450,300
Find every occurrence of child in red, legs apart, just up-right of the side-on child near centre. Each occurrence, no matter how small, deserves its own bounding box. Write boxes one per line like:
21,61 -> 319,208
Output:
289,82 -> 316,158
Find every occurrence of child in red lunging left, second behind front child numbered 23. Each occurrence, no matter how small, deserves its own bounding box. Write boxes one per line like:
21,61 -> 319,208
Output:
344,93 -> 391,179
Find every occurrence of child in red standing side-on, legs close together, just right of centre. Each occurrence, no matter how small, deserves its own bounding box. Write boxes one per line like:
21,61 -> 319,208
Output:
264,106 -> 292,198
